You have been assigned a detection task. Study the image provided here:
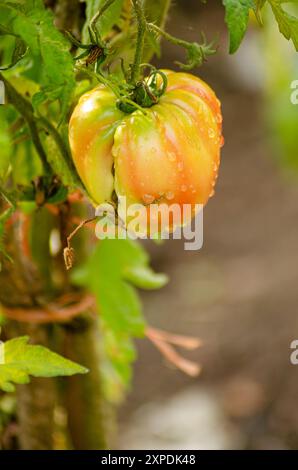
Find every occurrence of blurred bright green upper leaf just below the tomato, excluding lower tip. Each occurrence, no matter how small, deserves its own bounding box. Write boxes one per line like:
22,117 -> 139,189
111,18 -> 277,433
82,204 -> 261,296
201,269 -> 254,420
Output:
74,239 -> 167,336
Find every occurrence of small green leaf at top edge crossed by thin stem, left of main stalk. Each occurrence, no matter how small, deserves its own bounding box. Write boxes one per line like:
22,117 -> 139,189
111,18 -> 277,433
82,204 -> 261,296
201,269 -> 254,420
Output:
83,0 -> 124,42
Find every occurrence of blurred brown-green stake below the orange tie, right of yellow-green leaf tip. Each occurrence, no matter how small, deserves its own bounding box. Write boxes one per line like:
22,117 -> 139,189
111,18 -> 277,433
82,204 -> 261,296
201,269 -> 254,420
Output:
65,315 -> 110,450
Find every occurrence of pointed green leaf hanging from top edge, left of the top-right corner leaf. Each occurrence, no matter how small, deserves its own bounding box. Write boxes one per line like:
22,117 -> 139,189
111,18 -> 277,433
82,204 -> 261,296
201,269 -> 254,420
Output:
223,0 -> 254,54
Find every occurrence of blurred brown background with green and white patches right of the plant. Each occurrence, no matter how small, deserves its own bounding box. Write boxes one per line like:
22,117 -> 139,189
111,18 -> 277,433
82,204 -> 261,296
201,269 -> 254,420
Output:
115,0 -> 298,449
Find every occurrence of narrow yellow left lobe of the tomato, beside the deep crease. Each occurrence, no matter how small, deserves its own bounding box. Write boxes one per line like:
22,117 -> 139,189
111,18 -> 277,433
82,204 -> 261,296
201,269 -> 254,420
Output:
69,86 -> 125,204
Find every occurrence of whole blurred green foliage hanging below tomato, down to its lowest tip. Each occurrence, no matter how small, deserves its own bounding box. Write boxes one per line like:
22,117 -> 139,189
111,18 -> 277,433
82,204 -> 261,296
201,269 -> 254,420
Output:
73,239 -> 167,399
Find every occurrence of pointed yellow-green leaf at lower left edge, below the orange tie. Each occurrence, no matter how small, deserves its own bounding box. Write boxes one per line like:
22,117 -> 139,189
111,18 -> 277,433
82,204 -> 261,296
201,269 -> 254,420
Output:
0,336 -> 88,392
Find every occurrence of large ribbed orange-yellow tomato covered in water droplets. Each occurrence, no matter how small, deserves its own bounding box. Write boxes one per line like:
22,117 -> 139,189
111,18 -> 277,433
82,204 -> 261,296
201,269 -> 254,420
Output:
69,71 -> 223,231
